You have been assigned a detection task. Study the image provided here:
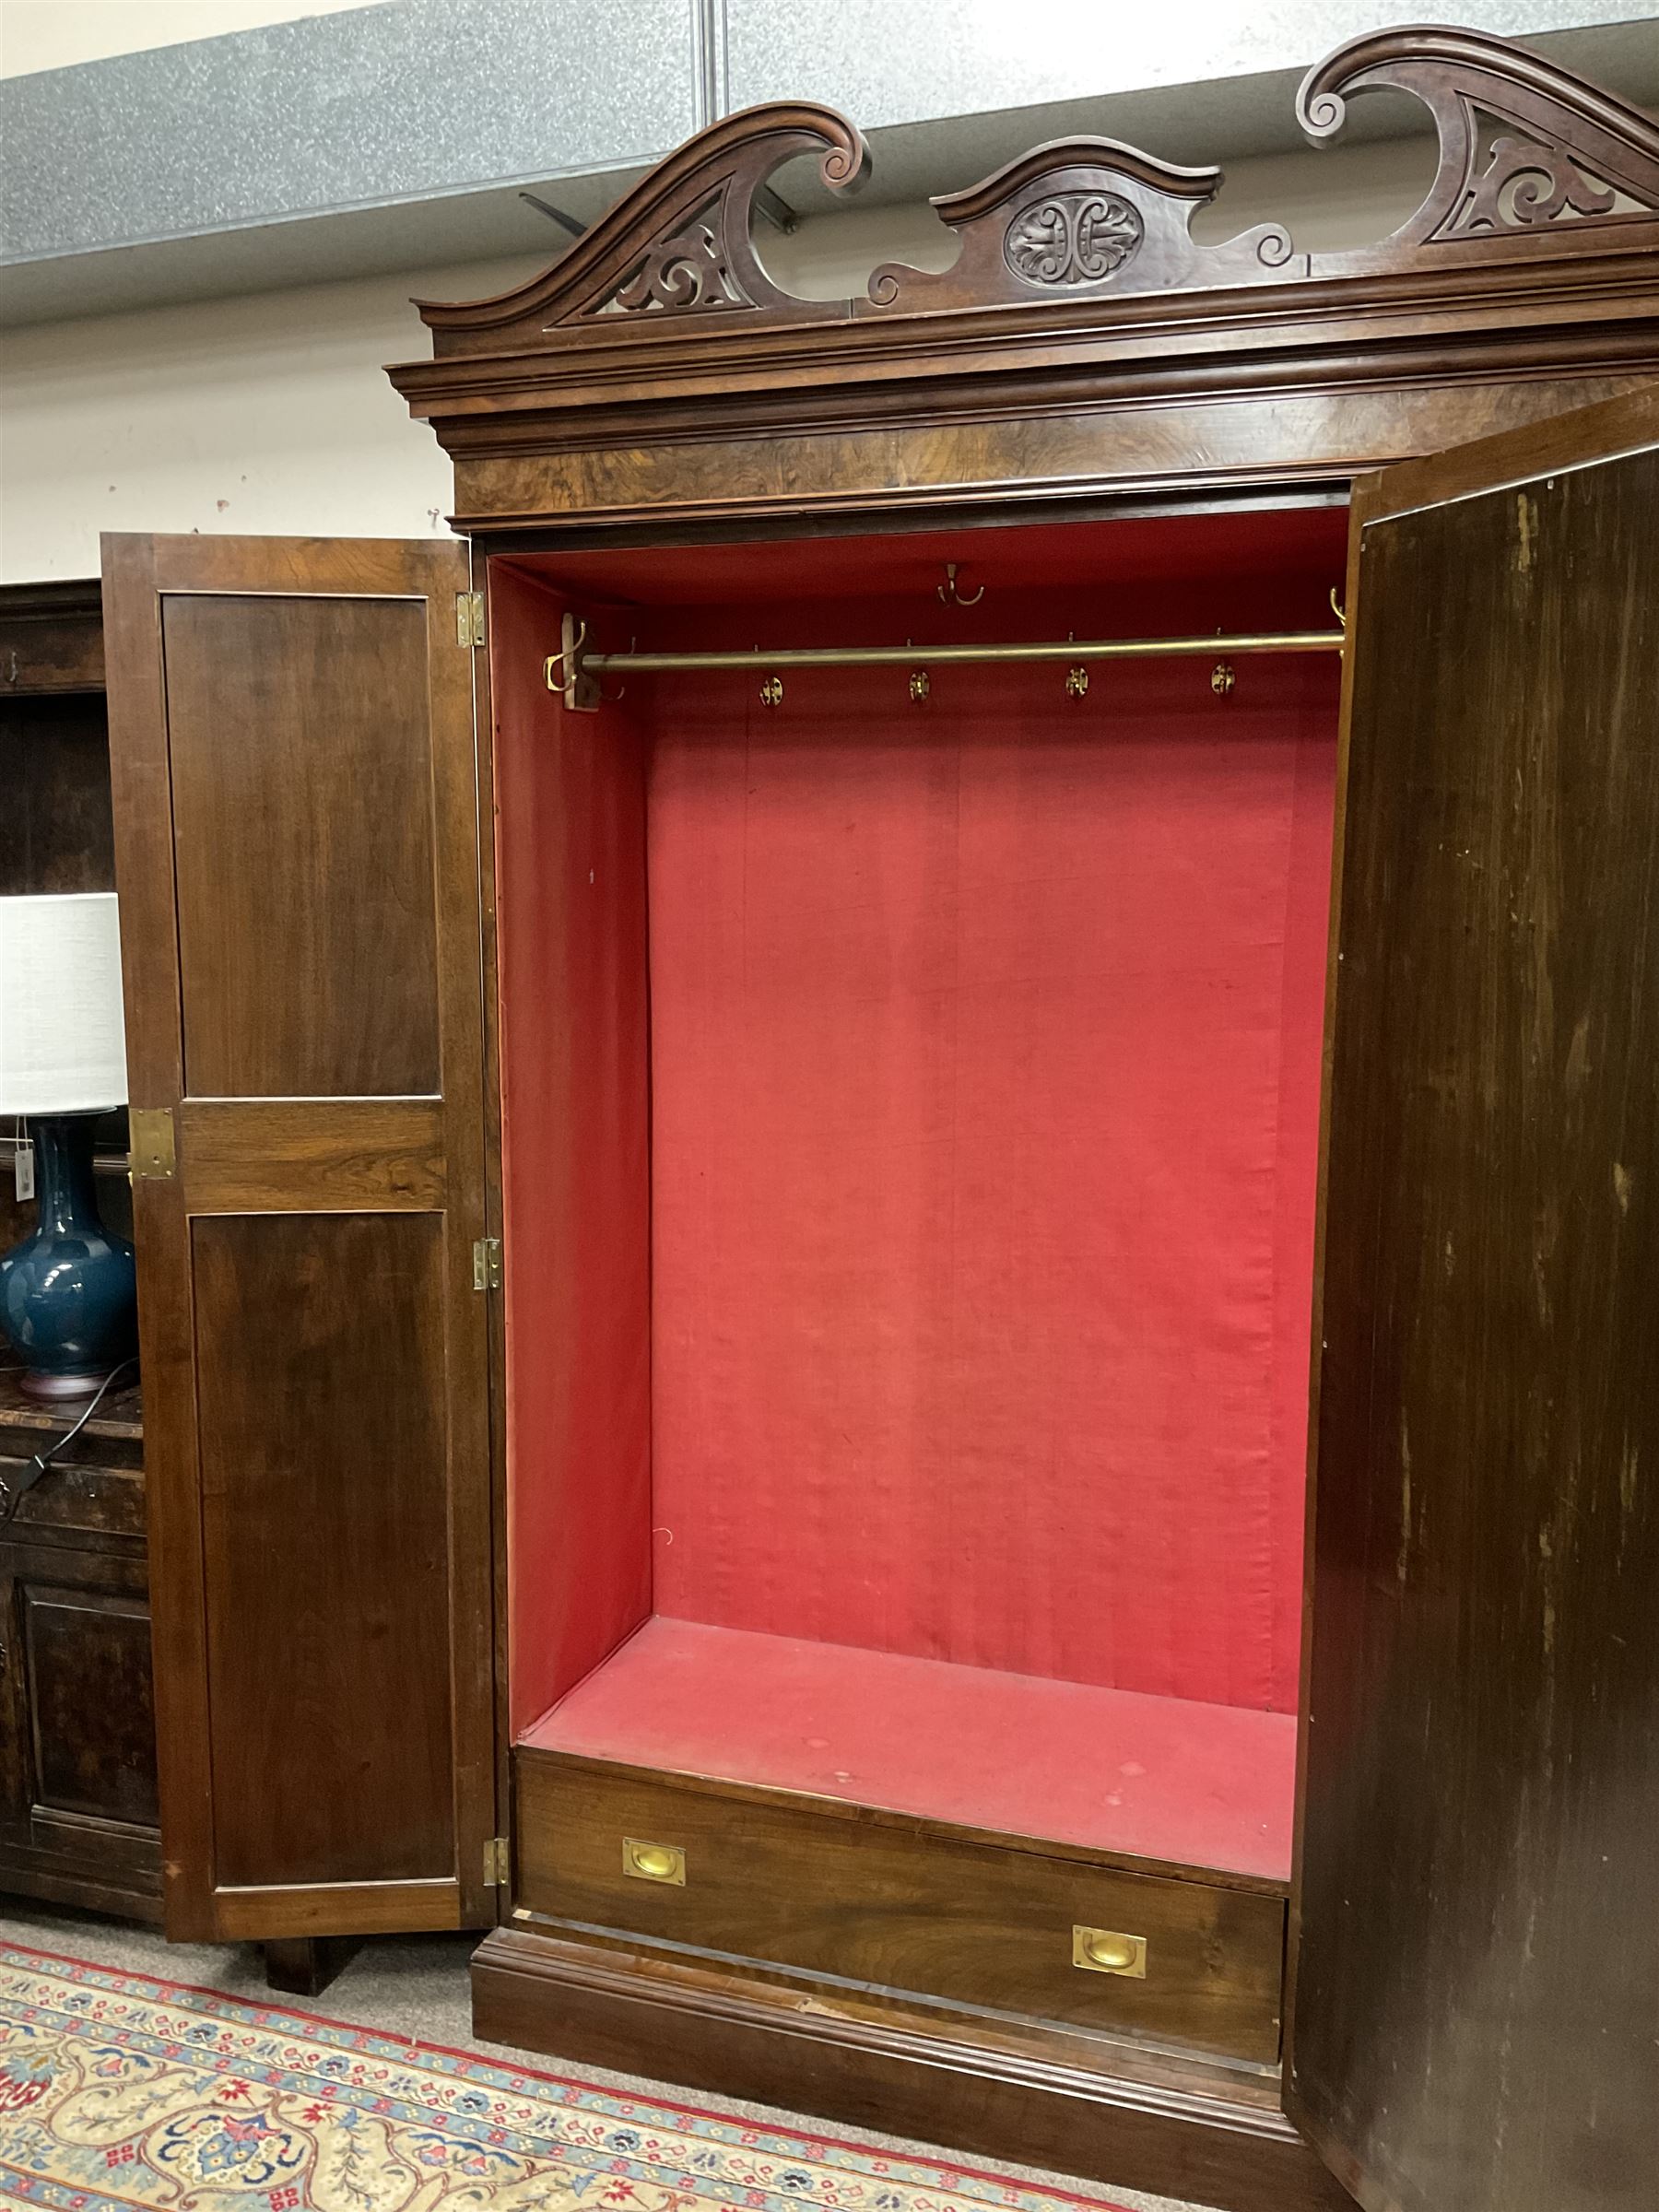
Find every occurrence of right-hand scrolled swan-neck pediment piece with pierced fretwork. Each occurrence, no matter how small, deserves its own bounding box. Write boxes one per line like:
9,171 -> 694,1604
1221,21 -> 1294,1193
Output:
1296,29 -> 1659,259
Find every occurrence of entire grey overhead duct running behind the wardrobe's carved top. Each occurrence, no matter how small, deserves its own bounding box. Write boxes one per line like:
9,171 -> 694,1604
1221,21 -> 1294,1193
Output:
0,0 -> 1659,323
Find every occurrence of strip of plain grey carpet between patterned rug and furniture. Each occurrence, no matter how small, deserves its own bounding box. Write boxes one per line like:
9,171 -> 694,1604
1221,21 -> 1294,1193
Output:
0,1898 -> 1204,2212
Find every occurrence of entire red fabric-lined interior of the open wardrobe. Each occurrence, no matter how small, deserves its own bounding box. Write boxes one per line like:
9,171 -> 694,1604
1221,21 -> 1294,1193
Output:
488,507 -> 1345,1882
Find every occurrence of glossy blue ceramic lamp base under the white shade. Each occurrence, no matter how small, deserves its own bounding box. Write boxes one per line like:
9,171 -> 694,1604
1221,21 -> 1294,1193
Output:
0,1112 -> 137,1398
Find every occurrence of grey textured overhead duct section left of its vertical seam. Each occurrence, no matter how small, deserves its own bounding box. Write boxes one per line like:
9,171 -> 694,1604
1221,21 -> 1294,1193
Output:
0,0 -> 697,261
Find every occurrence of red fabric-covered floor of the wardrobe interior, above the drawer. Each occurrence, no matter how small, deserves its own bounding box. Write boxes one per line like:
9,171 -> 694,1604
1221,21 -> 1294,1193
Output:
539,1619 -> 1296,1882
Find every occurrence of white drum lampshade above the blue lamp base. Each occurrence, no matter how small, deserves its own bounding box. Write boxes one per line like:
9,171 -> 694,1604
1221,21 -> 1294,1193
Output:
0,891 -> 126,1112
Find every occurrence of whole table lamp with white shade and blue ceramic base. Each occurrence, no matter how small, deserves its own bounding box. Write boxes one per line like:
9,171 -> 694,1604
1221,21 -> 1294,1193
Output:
0,891 -> 137,1398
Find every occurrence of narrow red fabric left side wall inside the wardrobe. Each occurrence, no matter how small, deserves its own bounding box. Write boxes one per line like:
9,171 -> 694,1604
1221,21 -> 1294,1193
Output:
488,562 -> 651,1730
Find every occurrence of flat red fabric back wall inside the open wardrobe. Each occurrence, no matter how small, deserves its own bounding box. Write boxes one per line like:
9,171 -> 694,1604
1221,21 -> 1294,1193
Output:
651,623 -> 1336,1710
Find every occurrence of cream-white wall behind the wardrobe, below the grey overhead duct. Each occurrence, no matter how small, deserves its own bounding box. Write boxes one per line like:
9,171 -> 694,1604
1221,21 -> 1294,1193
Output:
0,144 -> 1429,582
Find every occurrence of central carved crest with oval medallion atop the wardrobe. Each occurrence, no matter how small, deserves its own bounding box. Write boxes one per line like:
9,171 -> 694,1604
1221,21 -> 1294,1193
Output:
869,139 -> 1292,310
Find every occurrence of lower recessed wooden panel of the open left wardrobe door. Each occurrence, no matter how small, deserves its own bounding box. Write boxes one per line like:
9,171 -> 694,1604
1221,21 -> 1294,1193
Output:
193,1215 -> 453,1885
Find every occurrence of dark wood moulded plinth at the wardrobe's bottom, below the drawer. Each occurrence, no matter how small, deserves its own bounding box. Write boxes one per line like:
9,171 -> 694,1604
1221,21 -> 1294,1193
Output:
474,1926 -> 1349,2212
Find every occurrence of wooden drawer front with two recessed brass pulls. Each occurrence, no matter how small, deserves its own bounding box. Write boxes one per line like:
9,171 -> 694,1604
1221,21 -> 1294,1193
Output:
515,1747 -> 1285,2064
